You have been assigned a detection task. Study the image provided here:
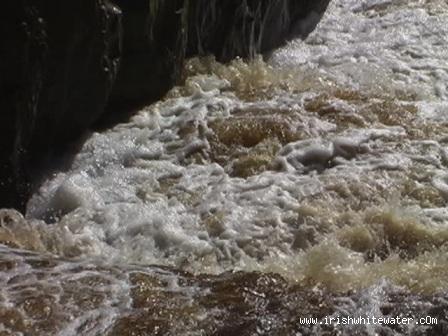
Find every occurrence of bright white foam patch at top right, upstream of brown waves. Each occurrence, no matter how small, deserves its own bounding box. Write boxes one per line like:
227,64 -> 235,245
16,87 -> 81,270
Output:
272,0 -> 448,100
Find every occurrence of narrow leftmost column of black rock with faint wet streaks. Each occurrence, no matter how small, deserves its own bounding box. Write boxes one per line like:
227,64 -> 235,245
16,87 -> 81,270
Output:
0,1 -> 47,207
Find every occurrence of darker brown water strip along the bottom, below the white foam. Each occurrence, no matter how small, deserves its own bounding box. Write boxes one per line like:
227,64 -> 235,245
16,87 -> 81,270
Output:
0,244 -> 448,335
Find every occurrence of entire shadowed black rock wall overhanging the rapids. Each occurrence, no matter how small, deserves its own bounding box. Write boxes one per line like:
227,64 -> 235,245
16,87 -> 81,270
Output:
0,0 -> 329,210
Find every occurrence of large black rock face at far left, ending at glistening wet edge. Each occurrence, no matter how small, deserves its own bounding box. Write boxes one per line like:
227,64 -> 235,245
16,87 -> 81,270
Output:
0,0 -> 121,208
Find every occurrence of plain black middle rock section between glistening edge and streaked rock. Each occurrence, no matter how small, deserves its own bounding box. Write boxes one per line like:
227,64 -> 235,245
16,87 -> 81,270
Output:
109,0 -> 187,113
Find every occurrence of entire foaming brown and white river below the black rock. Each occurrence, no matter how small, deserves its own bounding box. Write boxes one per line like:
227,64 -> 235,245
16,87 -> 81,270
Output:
0,0 -> 448,335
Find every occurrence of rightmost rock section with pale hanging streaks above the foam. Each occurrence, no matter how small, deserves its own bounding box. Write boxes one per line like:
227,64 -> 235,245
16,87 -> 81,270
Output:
188,0 -> 330,62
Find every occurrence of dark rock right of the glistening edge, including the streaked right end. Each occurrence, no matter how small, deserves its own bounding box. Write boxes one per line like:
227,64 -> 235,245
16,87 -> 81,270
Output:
106,0 -> 329,113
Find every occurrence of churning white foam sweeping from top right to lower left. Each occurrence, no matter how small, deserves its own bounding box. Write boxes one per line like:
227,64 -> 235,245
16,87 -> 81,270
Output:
15,0 -> 448,290
